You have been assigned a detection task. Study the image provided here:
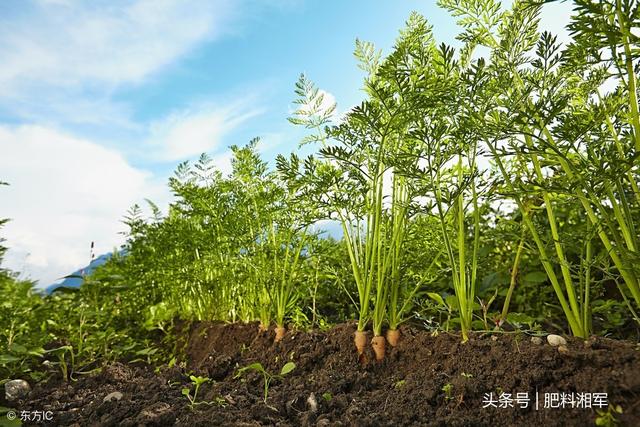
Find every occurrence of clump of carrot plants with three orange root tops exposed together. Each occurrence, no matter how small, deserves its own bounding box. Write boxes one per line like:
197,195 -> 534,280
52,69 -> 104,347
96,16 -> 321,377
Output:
282,50 -> 420,360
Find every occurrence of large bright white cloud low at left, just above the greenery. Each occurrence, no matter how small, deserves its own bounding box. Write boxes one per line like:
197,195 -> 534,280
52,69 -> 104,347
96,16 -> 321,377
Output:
0,125 -> 169,285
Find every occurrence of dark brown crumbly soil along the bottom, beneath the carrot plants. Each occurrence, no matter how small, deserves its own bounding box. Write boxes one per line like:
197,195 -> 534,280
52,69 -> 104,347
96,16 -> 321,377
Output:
8,323 -> 640,426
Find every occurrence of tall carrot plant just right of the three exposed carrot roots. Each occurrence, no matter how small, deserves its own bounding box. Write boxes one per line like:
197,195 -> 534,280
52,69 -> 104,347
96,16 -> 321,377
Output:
376,14 -> 484,340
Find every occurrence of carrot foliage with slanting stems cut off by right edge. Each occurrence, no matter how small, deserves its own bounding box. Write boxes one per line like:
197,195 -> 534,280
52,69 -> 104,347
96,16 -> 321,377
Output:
552,0 -> 640,307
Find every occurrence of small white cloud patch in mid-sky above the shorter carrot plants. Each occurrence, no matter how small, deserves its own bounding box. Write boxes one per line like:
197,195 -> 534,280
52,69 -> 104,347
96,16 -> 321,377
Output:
150,101 -> 262,161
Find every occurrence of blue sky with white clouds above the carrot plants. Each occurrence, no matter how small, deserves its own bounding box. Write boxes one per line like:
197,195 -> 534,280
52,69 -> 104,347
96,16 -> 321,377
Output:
0,0 -> 570,286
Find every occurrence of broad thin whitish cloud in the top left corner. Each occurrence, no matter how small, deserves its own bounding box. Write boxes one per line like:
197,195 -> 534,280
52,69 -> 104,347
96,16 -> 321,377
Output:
0,0 -> 232,93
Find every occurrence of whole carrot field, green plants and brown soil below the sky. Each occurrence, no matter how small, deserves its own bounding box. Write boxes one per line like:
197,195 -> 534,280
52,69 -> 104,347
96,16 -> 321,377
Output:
0,0 -> 640,426
